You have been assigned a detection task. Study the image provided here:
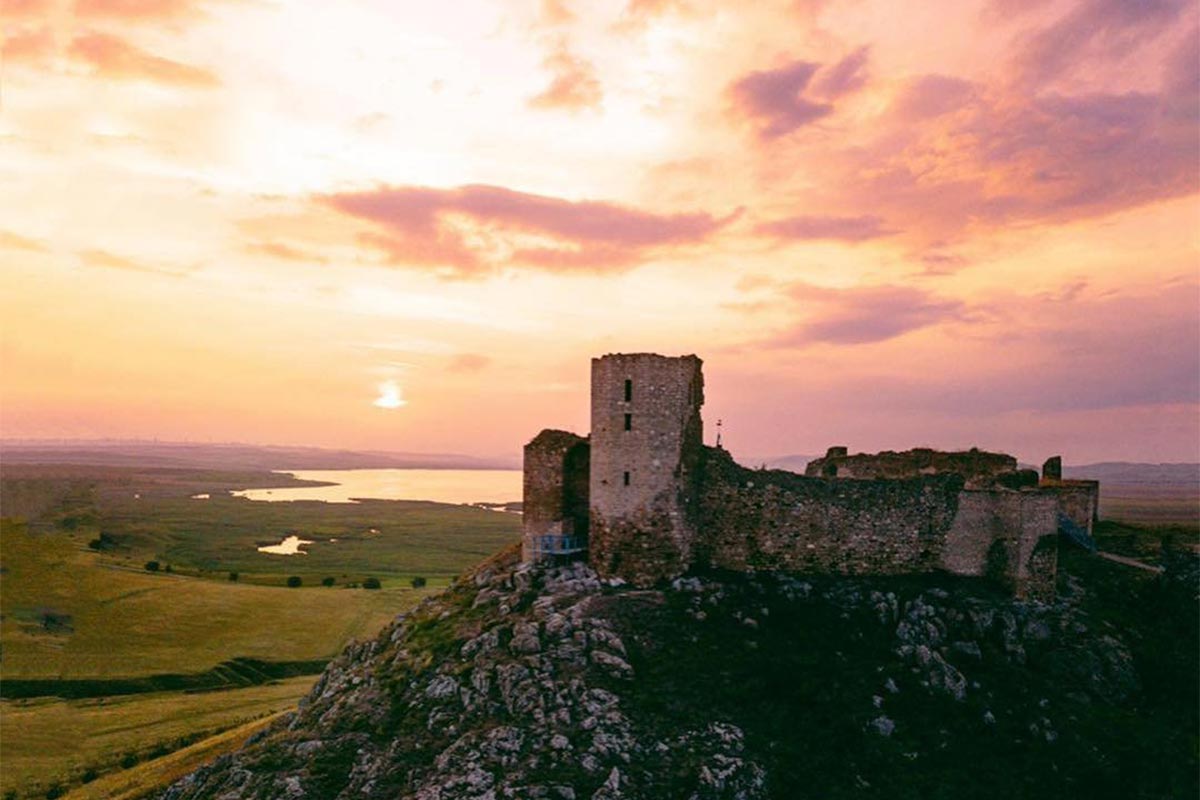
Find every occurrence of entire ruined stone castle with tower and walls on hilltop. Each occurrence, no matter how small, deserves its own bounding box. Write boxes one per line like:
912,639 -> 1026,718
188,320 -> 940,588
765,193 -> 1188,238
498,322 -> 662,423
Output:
522,353 -> 1099,600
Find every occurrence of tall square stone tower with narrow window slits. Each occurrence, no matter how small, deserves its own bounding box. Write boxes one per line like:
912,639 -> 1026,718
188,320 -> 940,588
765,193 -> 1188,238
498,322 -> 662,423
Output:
588,353 -> 704,585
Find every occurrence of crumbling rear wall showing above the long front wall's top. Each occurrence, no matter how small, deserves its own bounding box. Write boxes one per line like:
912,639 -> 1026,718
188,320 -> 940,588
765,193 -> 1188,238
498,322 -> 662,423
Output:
804,447 -> 1016,486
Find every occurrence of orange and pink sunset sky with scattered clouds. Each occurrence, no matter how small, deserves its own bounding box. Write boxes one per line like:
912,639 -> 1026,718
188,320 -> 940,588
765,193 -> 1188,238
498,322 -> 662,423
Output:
0,0 -> 1200,463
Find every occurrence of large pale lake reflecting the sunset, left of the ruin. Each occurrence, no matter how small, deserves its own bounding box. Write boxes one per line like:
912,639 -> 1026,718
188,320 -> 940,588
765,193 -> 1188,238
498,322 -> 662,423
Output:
233,469 -> 522,503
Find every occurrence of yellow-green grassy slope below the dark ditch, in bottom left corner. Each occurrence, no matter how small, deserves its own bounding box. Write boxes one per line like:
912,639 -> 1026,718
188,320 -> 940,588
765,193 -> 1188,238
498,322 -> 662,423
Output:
0,675 -> 316,796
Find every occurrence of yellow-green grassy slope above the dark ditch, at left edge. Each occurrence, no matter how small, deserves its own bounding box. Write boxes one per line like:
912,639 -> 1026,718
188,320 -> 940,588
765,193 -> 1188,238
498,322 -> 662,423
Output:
0,524 -> 424,678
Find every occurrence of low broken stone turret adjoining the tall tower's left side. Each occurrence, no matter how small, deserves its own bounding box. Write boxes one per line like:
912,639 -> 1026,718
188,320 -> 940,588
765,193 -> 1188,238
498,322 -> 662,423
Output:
521,431 -> 589,561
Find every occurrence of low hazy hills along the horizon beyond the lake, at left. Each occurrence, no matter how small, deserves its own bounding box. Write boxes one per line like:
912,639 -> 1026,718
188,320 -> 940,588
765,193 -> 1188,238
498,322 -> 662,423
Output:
0,440 -> 521,470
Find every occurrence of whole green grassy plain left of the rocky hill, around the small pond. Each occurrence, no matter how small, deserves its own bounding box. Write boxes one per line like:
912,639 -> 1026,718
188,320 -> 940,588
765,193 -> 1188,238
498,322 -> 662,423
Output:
0,465 -> 520,798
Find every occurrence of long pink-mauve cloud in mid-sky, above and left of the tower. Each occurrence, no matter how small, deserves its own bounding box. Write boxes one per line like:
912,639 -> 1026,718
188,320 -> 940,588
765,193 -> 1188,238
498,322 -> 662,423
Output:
320,185 -> 733,275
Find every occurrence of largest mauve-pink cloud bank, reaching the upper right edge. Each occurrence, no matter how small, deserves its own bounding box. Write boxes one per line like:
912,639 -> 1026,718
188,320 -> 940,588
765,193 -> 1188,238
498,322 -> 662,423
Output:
806,40 -> 1200,241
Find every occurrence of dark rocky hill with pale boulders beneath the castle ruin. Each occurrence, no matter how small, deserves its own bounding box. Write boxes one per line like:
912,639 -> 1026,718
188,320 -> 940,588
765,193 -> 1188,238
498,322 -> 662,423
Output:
160,542 -> 1196,800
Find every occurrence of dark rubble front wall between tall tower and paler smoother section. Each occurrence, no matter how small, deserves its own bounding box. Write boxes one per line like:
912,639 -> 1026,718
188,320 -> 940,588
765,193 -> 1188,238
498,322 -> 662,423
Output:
695,449 -> 962,575
